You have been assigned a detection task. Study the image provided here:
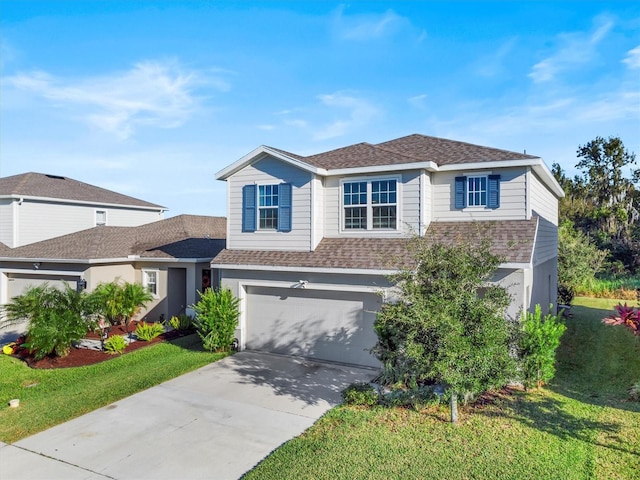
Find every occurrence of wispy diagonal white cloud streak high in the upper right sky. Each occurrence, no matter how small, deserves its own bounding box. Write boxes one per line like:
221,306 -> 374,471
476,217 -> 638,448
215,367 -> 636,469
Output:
529,18 -> 613,83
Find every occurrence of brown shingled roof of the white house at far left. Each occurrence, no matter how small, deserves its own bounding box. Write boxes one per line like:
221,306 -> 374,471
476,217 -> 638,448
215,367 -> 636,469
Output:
0,172 -> 166,210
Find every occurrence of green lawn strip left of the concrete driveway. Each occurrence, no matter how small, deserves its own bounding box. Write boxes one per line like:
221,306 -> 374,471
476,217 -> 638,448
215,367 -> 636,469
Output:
0,334 -> 225,443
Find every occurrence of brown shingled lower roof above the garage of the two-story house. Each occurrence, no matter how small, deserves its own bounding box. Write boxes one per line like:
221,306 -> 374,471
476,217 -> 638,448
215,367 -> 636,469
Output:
212,217 -> 538,271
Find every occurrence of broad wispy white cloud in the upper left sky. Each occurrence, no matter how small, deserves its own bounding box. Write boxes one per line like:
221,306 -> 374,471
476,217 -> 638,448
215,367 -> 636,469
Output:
5,61 -> 229,139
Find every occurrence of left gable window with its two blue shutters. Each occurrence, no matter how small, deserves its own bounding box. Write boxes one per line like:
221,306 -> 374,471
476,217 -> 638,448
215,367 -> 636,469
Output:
242,183 -> 292,232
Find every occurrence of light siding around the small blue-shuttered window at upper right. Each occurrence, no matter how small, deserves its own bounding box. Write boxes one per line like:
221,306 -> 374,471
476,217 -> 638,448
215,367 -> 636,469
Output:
431,167 -> 527,221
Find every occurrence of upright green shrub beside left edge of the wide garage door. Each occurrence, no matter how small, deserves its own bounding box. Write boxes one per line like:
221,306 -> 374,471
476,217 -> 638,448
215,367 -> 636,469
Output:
193,288 -> 240,352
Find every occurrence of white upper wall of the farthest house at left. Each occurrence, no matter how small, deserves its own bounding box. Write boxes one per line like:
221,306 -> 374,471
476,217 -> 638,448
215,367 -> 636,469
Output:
14,199 -> 162,246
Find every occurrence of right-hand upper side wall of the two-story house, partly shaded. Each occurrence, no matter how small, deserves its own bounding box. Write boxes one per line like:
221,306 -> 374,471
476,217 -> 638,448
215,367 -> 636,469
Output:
528,171 -> 558,265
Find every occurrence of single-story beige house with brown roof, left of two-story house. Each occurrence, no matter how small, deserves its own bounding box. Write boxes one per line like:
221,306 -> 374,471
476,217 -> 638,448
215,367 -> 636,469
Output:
0,215 -> 226,321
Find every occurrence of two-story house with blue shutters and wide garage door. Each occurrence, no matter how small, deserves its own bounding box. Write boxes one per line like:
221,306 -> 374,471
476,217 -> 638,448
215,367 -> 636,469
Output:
212,135 -> 564,366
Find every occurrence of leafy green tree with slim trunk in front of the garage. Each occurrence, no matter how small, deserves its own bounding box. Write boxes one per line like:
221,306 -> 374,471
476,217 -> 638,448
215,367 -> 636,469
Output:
373,232 -> 515,422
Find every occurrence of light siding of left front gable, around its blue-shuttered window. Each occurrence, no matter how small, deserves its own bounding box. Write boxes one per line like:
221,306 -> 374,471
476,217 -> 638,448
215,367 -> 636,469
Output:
227,156 -> 311,251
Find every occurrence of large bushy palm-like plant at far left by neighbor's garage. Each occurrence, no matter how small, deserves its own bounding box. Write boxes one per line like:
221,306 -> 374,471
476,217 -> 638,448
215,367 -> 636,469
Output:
2,284 -> 95,359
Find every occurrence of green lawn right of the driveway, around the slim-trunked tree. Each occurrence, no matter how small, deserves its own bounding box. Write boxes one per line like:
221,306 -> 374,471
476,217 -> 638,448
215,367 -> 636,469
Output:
246,298 -> 640,479
